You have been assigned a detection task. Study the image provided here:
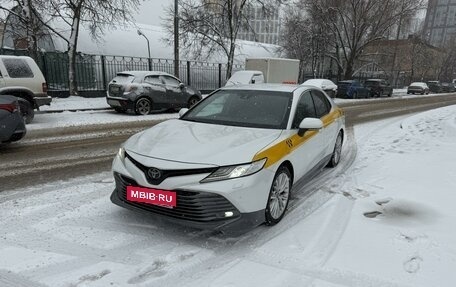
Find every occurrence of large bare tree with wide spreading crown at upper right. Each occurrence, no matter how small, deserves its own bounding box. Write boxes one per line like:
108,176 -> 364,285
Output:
286,0 -> 424,78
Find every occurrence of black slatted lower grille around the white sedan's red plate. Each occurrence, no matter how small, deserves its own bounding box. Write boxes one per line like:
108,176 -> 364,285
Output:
114,173 -> 240,222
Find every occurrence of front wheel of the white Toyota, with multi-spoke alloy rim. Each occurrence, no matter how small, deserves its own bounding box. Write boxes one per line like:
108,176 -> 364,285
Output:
265,166 -> 293,226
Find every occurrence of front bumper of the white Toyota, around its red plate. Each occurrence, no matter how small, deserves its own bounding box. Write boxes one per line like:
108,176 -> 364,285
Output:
111,152 -> 274,231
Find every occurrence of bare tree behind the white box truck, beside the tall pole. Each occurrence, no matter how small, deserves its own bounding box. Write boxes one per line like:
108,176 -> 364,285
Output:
165,0 -> 279,77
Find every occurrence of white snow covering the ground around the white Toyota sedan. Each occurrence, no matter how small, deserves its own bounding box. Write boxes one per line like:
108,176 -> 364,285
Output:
0,97 -> 456,287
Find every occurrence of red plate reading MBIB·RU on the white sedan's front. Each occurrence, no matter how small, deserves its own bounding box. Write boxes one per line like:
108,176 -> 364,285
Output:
127,186 -> 177,208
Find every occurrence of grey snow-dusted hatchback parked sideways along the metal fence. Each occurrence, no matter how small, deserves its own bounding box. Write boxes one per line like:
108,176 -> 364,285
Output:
106,71 -> 201,115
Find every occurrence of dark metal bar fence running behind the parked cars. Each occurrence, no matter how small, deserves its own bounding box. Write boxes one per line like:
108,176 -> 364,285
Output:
0,49 -> 244,97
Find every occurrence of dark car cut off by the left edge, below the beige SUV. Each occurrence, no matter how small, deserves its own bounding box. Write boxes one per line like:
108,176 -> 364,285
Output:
0,95 -> 27,143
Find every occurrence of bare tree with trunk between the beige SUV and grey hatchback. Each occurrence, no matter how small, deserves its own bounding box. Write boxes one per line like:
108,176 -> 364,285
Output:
0,0 -> 140,95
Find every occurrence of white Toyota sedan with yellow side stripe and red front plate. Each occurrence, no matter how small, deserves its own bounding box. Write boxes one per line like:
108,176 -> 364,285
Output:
111,84 -> 345,233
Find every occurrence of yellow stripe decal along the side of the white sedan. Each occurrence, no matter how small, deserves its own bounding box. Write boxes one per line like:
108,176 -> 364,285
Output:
252,108 -> 343,168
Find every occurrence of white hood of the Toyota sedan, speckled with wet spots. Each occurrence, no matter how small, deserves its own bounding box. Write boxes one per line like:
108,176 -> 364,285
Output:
124,119 -> 282,166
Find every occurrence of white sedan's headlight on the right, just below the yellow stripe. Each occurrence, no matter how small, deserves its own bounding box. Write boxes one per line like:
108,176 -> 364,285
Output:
200,158 -> 267,183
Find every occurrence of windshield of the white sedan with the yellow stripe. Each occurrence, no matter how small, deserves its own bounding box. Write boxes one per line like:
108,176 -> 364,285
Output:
181,90 -> 293,129
